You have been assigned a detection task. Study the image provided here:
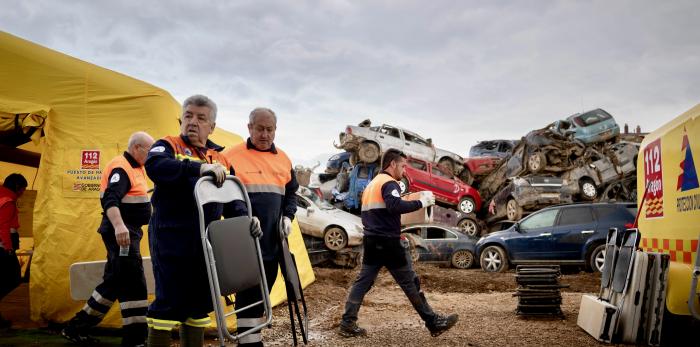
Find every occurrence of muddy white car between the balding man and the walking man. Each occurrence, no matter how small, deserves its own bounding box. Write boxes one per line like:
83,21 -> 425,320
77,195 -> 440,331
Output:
295,187 -> 363,251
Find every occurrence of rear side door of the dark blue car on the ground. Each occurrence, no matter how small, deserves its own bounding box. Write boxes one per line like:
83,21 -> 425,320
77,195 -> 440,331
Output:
550,206 -> 597,260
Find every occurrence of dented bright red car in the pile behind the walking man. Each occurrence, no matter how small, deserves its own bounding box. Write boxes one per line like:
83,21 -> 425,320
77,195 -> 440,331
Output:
399,158 -> 481,213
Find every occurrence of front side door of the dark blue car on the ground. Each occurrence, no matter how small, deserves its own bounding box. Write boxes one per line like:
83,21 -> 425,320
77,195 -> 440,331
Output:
505,208 -> 559,260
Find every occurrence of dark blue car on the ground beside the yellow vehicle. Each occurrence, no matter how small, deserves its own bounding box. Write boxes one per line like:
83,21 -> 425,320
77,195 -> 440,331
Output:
476,203 -> 637,272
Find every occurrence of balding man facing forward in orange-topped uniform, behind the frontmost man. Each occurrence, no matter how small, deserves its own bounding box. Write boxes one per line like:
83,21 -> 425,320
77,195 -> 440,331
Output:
224,108 -> 299,346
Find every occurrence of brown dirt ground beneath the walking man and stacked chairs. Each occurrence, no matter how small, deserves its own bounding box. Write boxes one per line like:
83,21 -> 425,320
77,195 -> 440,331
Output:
263,264 -> 600,347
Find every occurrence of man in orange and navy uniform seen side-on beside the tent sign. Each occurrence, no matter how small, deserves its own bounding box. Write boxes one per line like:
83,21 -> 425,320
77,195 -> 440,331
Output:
61,132 -> 153,346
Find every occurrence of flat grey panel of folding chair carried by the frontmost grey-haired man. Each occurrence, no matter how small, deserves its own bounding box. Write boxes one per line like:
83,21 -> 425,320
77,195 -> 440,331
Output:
208,216 -> 261,295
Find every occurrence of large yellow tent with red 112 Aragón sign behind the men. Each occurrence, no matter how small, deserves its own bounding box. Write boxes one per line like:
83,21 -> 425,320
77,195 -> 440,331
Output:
0,32 -> 314,326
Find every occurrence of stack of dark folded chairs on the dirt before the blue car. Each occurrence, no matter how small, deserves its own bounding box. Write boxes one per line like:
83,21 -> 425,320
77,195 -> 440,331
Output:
513,265 -> 568,317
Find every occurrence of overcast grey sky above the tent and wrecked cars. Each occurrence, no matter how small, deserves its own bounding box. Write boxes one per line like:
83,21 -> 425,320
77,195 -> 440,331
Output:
0,0 -> 700,168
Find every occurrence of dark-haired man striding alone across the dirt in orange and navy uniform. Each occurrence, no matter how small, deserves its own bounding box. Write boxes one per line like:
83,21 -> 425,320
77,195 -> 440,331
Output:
340,149 -> 459,337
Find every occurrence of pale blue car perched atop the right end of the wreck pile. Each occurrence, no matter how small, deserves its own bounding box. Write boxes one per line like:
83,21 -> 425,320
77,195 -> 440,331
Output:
566,108 -> 620,144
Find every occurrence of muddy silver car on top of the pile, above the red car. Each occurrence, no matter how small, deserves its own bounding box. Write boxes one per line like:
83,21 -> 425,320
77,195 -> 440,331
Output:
335,120 -> 464,175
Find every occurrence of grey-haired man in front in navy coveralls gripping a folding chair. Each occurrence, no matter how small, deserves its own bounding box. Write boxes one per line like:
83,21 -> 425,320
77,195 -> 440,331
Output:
146,95 -> 261,346
